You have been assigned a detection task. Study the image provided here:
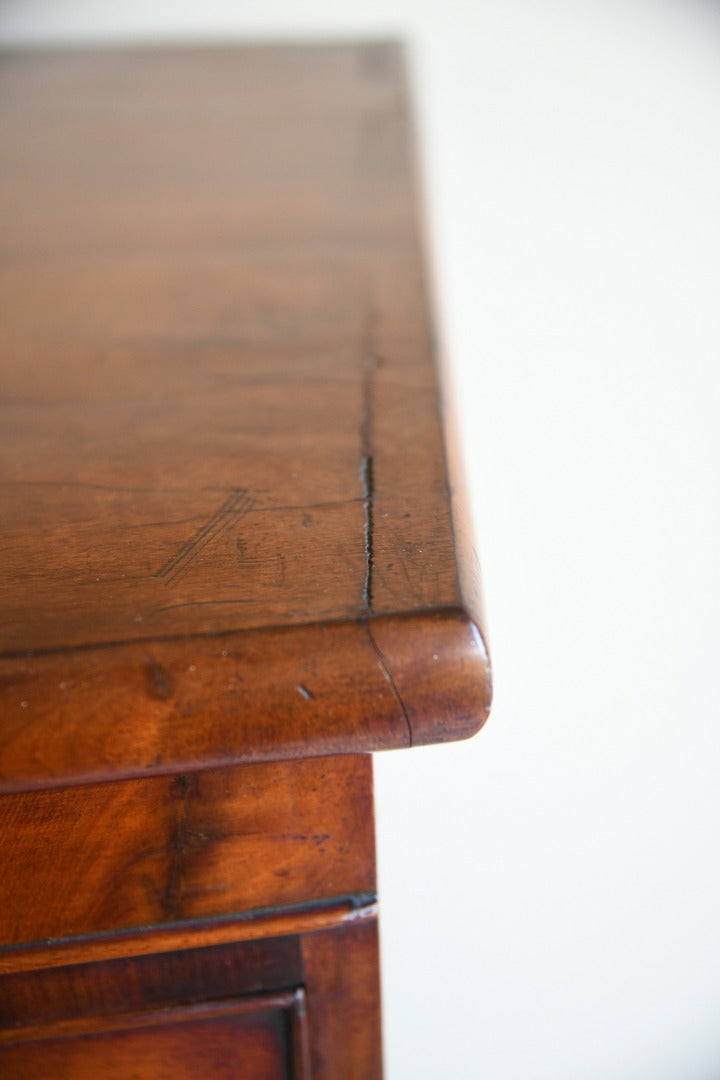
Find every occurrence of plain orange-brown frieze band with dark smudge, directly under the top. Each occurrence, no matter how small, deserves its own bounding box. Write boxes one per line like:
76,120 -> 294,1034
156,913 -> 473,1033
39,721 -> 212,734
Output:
0,756 -> 376,956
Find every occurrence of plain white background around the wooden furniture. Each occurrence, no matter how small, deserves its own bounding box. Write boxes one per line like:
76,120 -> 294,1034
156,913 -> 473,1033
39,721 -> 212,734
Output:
0,0 -> 720,1080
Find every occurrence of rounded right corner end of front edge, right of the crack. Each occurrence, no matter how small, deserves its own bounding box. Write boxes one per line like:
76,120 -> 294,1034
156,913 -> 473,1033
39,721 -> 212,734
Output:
362,607 -> 492,745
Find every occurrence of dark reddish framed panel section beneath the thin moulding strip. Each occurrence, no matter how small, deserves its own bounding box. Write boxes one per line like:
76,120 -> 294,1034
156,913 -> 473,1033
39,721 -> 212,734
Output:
0,908 -> 382,1080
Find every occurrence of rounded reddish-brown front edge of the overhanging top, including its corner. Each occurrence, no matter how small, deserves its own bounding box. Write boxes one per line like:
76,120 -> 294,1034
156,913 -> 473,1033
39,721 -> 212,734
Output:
0,610 -> 488,791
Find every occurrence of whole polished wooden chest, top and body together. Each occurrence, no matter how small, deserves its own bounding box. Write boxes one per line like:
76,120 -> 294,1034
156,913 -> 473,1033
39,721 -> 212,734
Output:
0,43 -> 489,1080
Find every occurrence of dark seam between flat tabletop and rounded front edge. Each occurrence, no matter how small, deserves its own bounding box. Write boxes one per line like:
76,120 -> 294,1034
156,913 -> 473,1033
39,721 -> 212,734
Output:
0,600 -> 470,660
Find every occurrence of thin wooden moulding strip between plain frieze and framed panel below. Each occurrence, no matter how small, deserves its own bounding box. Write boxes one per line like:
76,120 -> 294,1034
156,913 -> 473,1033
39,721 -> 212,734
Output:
0,892 -> 378,959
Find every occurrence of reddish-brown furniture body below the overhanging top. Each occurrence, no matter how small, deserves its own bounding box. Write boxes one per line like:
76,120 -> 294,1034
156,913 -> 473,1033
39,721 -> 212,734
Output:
0,755 -> 380,1080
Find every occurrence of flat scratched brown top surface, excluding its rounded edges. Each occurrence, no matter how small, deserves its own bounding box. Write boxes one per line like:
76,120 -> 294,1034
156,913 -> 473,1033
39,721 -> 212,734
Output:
0,39 -> 457,649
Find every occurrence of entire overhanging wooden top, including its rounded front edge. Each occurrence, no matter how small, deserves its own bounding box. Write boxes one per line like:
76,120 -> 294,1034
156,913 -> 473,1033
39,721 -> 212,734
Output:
0,44 -> 488,786
